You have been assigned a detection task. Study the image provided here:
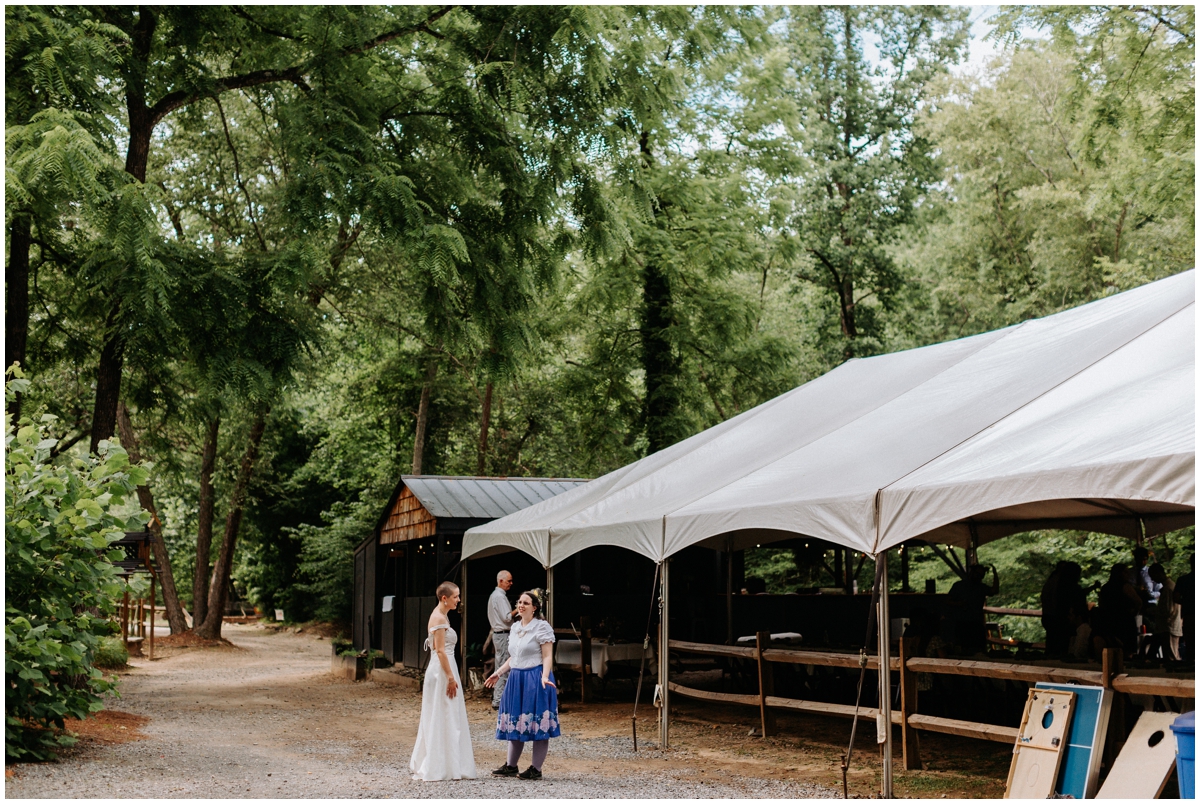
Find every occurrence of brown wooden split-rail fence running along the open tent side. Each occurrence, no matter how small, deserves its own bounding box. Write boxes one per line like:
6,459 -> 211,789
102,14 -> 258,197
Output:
668,631 -> 1195,770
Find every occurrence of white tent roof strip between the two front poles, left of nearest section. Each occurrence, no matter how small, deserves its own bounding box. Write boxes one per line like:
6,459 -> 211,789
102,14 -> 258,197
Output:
664,272 -> 1194,556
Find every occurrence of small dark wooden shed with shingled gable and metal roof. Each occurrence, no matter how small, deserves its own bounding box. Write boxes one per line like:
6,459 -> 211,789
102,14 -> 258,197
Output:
352,475 -> 587,668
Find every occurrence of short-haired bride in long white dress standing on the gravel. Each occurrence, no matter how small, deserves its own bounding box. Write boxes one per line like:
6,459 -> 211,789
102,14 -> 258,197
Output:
408,582 -> 476,781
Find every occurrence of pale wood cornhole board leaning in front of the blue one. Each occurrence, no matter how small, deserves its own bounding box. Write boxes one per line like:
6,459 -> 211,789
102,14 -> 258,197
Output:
1004,689 -> 1075,798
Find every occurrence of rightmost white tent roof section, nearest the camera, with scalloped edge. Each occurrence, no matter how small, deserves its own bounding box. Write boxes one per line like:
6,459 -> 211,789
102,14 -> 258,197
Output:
877,305 -> 1195,550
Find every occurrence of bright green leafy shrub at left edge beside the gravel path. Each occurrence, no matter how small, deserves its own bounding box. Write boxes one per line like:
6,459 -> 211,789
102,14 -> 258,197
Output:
4,372 -> 146,760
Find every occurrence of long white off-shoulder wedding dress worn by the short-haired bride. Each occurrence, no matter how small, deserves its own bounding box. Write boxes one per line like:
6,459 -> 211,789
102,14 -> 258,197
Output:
408,625 -> 476,781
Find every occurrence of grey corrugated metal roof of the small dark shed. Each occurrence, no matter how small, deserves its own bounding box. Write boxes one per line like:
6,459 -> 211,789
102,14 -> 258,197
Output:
401,475 -> 587,520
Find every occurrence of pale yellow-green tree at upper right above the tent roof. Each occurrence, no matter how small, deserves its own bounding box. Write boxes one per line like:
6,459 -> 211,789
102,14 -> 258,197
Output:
904,7 -> 1195,340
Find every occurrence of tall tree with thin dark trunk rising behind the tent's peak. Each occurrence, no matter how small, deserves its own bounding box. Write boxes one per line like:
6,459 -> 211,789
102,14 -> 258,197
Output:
784,6 -> 967,360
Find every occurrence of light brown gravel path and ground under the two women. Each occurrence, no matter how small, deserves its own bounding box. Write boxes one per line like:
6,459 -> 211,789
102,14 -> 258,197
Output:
5,625 -> 838,799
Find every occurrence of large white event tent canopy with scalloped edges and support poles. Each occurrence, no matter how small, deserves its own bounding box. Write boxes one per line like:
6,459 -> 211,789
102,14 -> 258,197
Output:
462,271 -> 1195,796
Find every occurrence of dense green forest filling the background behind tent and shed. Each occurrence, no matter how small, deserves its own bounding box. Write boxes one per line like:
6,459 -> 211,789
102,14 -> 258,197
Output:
5,6 -> 1195,632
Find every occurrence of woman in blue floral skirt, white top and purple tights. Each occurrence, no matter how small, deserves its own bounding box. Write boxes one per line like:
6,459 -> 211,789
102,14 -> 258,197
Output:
484,589 -> 560,779
